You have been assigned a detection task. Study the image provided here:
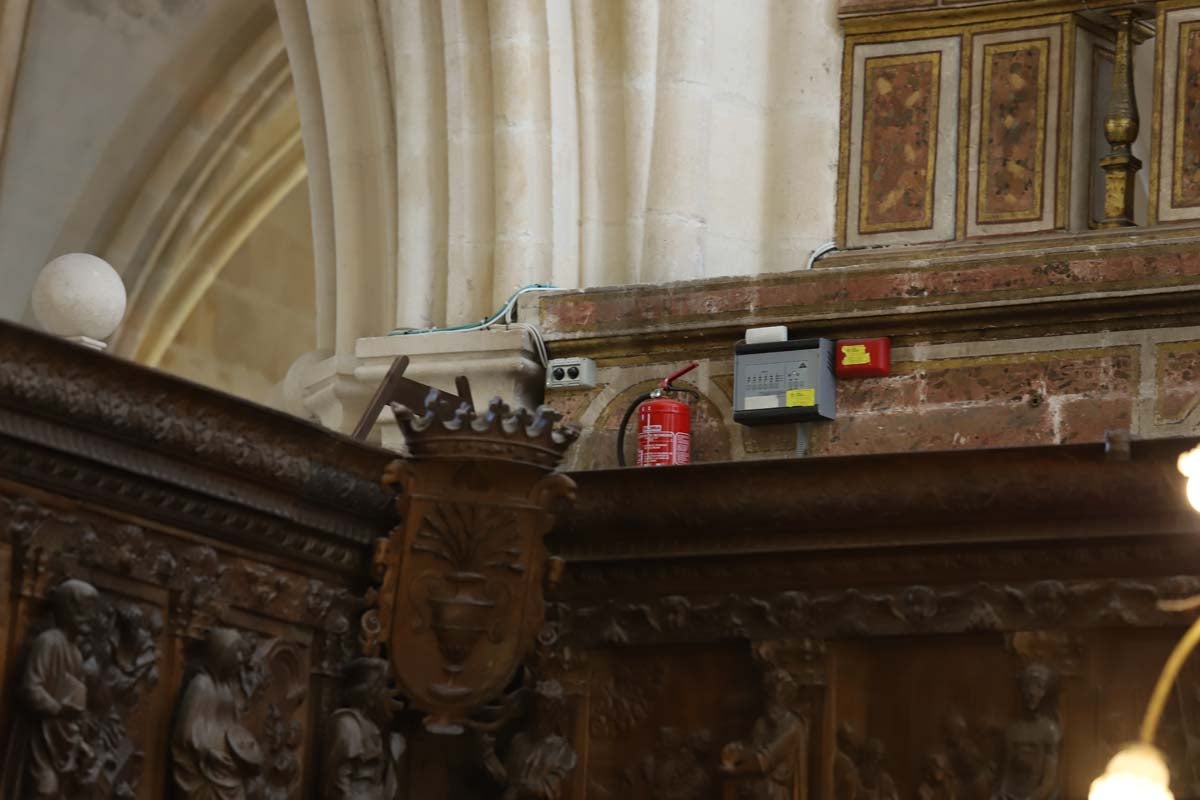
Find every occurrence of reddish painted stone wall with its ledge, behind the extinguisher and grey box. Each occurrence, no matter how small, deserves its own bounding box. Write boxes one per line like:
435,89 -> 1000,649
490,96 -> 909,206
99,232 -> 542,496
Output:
526,230 -> 1200,469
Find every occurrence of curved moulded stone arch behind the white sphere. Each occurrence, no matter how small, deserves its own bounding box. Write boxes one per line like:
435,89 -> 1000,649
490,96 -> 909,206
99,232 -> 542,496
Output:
101,20 -> 307,366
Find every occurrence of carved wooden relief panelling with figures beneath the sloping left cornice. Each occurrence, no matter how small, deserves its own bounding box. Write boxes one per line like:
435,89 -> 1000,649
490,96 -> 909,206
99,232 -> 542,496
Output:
0,495 -> 360,800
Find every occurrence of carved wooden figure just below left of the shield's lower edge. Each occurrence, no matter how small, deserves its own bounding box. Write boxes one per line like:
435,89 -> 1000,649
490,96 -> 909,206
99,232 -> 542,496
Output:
320,658 -> 406,800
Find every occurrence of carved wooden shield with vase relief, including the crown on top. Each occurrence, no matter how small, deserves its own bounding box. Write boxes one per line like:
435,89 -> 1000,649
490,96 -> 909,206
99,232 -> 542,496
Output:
362,390 -> 578,733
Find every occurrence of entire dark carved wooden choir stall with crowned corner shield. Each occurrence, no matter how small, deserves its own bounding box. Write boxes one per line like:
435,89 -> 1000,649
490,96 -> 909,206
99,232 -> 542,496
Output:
0,325 -> 1200,800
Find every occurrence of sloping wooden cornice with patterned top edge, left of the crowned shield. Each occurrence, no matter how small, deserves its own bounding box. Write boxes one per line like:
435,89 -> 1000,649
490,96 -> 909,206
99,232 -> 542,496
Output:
0,323 -> 392,531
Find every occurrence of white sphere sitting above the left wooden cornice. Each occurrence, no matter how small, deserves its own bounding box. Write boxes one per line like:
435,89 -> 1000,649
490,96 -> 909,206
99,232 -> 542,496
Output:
32,253 -> 125,347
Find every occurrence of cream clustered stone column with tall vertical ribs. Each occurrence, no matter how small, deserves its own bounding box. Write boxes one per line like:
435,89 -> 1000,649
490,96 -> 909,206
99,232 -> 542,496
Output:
276,0 -> 841,429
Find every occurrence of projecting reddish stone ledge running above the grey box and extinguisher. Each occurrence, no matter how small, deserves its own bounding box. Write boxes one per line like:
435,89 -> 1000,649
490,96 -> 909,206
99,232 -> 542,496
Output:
529,228 -> 1200,359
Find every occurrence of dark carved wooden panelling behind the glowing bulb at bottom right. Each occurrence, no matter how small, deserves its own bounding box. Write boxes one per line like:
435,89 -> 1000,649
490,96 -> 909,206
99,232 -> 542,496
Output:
832,631 -> 1200,800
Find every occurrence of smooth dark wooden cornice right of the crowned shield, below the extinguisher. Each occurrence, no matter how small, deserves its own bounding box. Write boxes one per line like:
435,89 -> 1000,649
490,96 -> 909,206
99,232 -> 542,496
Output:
548,439 -> 1200,563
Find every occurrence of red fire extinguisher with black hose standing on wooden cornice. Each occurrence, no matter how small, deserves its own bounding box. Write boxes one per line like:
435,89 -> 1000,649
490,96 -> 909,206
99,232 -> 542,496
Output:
617,361 -> 700,467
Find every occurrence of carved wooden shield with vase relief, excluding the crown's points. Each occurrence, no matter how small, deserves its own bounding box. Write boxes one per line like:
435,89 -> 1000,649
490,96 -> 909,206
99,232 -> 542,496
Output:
372,464 -> 574,733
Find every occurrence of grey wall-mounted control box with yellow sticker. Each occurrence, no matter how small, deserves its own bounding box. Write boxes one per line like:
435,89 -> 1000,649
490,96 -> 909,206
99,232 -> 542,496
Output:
733,339 -> 835,425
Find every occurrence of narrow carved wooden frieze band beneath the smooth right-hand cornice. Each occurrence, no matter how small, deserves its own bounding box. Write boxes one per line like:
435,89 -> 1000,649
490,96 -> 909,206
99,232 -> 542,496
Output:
552,575 -> 1200,648
